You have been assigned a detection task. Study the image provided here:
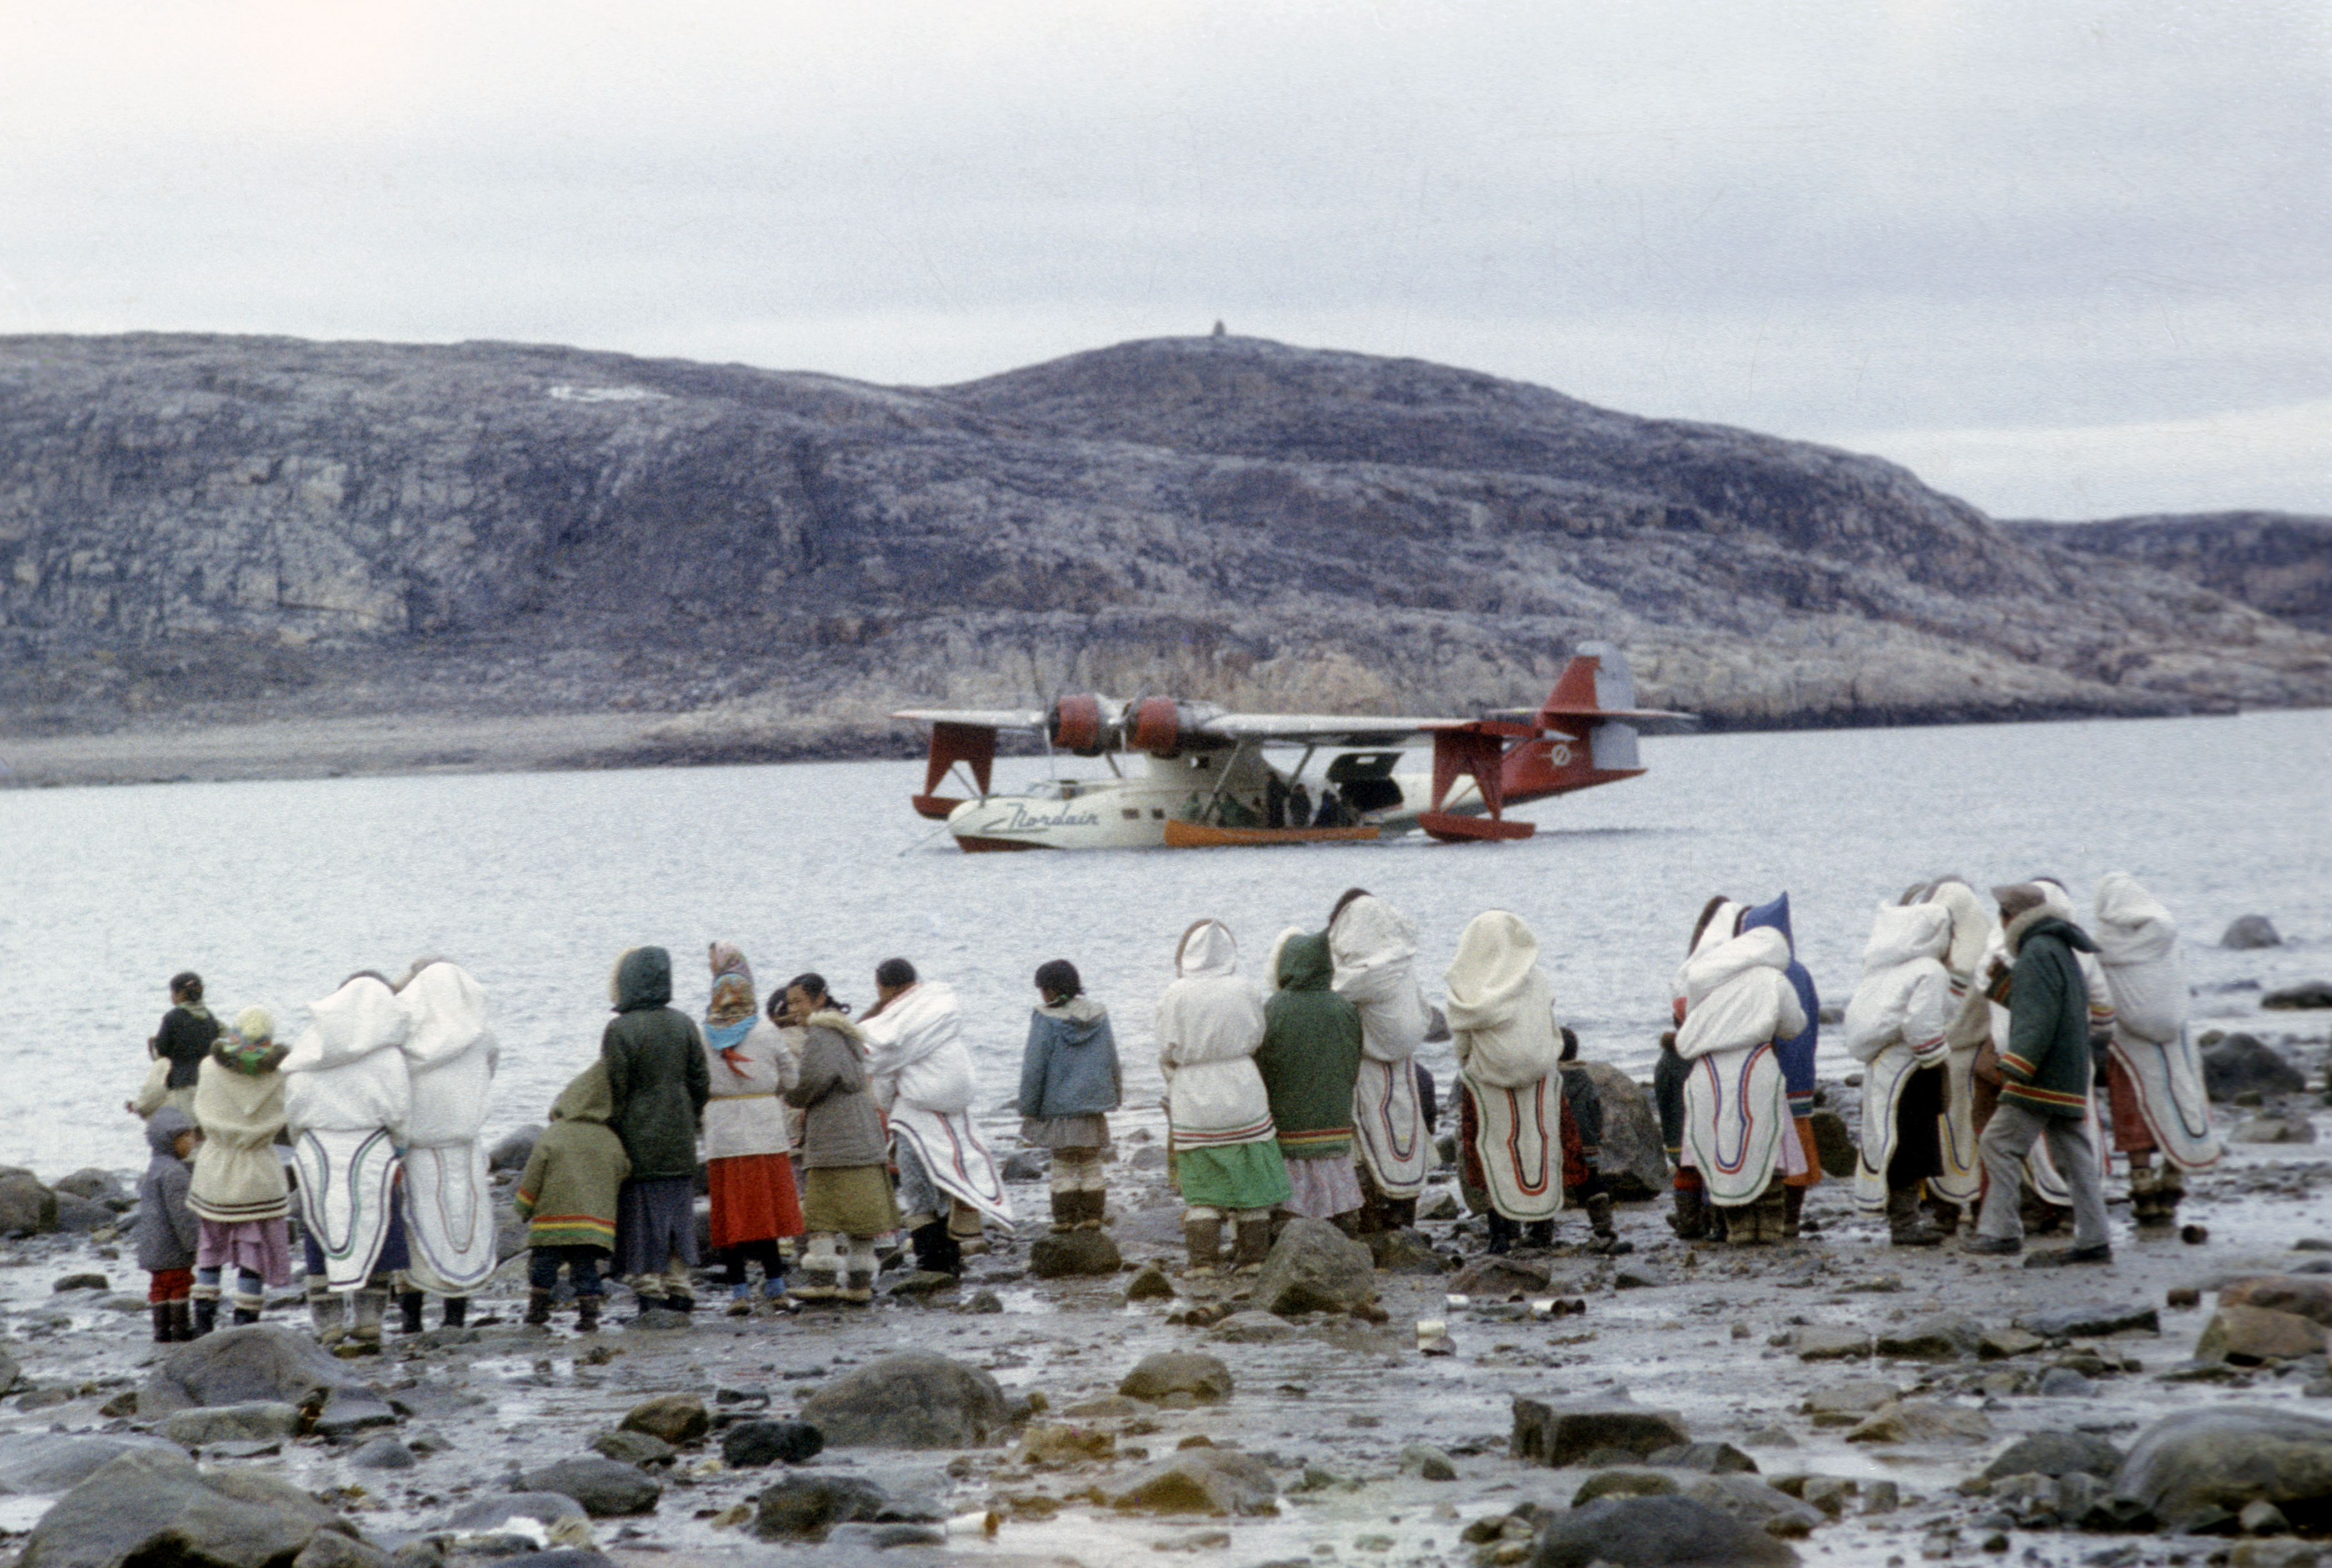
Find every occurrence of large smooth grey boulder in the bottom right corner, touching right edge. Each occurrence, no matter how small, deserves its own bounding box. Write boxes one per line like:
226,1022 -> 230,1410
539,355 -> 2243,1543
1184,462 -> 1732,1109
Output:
2113,1405 -> 2332,1531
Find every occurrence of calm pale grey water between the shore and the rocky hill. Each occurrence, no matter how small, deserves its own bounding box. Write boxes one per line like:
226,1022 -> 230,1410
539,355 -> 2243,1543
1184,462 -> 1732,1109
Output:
0,712 -> 2332,1176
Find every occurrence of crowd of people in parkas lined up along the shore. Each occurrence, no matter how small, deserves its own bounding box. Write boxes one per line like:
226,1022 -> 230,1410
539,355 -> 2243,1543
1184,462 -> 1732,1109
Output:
130,873 -> 2220,1351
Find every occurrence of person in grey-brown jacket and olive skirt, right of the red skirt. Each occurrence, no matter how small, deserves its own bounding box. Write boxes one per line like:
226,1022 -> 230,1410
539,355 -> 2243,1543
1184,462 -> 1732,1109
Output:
770,976 -> 898,1304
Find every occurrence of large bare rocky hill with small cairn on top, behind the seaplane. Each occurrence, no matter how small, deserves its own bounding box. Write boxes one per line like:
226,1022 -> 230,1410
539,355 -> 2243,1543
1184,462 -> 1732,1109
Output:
0,336 -> 2332,761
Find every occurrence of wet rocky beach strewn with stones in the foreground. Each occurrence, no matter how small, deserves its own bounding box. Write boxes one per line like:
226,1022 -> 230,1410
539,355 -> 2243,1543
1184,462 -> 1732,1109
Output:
0,1013 -> 2332,1568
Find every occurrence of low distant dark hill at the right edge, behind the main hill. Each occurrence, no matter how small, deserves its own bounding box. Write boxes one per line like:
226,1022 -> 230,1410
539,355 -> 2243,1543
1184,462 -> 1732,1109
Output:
2003,511 -> 2332,632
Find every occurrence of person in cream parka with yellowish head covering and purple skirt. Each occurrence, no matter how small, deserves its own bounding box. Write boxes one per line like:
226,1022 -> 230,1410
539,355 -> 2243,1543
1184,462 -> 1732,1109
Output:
187,1008 -> 292,1339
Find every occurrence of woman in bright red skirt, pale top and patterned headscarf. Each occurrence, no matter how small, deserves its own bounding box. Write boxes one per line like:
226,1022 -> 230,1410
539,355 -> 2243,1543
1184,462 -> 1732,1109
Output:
704,943 -> 802,1318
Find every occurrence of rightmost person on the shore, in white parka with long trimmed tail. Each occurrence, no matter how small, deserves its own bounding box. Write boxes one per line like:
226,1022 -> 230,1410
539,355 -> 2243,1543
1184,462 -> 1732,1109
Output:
2089,870 -> 2227,1227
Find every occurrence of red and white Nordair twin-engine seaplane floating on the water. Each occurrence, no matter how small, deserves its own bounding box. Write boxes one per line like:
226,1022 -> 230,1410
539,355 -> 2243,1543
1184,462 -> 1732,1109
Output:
891,644 -> 1698,854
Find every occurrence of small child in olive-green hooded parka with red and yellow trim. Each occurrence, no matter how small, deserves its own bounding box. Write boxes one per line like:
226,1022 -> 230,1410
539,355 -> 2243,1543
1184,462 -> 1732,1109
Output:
513,1062 -> 632,1335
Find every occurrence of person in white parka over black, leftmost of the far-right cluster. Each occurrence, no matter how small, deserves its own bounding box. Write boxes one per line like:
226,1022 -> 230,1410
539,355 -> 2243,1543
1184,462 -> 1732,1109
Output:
1847,903 -> 1952,1246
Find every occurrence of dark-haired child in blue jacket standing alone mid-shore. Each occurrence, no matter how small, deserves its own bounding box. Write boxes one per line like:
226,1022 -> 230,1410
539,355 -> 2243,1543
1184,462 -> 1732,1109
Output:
1019,959 -> 1124,1234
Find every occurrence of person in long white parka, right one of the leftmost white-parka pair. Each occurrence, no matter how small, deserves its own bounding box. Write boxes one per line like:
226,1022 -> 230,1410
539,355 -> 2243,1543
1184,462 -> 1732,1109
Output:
396,959 -> 501,1335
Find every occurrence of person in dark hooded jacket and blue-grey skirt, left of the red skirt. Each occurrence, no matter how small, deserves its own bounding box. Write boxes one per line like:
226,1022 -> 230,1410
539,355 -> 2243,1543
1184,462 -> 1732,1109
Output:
599,947 -> 711,1311
